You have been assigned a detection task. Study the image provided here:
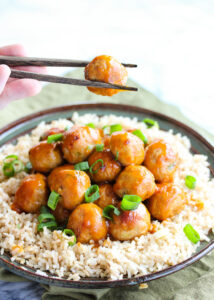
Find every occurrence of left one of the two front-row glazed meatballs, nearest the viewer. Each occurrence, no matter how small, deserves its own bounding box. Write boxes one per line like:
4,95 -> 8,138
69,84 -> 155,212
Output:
67,203 -> 107,243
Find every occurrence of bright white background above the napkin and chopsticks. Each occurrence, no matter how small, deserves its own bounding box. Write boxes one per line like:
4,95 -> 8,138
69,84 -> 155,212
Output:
0,0 -> 214,133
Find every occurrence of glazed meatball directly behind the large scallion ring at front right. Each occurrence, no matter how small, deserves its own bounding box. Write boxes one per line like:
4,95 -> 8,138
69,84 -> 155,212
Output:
113,165 -> 156,201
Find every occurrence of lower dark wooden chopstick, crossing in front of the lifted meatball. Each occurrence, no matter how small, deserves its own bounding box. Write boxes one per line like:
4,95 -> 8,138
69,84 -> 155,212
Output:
10,70 -> 137,91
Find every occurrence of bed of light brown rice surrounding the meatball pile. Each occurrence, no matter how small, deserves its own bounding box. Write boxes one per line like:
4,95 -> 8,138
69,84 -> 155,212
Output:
0,113 -> 214,280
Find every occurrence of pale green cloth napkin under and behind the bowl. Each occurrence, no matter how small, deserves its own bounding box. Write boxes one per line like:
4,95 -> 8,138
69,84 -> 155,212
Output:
0,69 -> 214,300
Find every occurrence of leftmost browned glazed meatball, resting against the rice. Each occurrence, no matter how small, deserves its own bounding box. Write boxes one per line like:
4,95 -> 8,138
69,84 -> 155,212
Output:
11,173 -> 48,213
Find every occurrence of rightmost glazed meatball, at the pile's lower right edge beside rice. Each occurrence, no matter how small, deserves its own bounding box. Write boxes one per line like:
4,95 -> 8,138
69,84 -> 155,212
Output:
147,183 -> 186,221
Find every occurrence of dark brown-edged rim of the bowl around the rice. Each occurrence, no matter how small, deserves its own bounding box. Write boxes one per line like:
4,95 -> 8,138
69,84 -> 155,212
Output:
0,102 -> 214,289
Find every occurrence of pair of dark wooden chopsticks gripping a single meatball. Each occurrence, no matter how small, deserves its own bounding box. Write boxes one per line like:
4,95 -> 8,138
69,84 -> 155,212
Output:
0,55 -> 137,91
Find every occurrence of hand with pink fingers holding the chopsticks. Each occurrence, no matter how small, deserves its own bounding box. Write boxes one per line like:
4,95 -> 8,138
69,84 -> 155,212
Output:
0,45 -> 46,109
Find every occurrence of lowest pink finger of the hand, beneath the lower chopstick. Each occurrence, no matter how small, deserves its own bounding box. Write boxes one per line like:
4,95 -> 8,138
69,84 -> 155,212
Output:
0,79 -> 41,108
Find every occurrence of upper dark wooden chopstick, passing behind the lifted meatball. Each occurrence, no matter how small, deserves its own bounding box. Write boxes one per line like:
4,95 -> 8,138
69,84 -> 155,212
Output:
0,55 -> 137,68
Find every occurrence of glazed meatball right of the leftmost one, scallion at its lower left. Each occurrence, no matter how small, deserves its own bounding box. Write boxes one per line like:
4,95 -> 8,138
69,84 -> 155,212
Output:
48,170 -> 91,210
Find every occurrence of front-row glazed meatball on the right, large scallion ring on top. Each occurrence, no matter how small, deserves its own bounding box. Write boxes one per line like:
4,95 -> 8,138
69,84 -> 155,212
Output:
109,203 -> 151,241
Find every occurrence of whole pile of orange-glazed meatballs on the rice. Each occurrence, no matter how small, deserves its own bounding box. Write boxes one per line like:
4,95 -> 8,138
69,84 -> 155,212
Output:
12,125 -> 185,243
